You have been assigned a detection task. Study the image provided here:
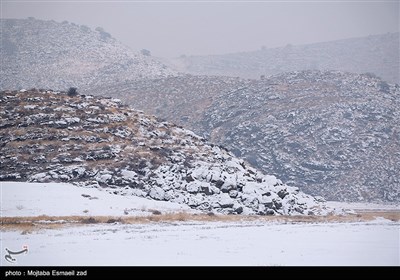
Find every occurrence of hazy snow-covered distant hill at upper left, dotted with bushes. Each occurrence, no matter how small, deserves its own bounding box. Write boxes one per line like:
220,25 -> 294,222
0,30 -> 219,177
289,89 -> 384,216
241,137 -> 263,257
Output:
0,19 -> 175,92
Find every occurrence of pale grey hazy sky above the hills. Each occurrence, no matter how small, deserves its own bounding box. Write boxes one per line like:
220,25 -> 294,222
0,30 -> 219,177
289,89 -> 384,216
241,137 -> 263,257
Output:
0,0 -> 400,57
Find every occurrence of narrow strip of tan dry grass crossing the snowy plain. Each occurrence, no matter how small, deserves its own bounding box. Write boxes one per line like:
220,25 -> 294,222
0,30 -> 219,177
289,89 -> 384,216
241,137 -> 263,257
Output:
0,210 -> 400,234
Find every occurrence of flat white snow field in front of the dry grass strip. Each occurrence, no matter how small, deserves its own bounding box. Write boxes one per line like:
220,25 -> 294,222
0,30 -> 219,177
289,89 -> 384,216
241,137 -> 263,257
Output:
1,220 -> 400,266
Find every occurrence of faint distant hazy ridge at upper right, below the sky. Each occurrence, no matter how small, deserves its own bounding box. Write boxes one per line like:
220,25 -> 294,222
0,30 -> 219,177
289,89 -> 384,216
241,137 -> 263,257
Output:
166,33 -> 400,83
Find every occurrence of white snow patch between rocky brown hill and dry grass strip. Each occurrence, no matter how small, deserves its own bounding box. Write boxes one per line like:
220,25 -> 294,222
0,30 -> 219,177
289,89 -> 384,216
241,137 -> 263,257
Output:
0,182 -> 193,217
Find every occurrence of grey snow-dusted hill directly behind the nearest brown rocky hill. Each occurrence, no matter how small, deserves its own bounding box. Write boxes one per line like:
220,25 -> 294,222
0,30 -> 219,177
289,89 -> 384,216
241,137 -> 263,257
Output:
97,71 -> 400,202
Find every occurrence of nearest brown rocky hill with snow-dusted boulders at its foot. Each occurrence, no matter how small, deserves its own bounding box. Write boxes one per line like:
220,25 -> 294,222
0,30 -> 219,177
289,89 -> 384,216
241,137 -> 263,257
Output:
0,90 -> 329,215
